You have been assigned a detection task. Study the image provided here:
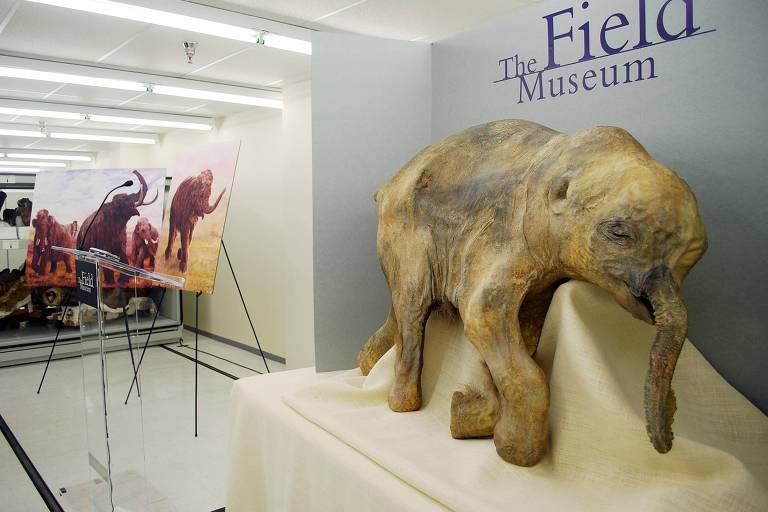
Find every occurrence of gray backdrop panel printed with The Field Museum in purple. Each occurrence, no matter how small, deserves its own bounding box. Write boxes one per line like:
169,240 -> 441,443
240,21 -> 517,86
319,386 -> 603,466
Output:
432,0 -> 768,411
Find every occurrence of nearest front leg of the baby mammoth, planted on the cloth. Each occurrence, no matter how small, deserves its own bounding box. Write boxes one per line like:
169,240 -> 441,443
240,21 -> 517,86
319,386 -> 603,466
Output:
462,289 -> 549,466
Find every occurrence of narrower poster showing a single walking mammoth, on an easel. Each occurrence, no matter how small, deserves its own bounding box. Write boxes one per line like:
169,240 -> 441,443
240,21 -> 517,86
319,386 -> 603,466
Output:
155,141 -> 240,293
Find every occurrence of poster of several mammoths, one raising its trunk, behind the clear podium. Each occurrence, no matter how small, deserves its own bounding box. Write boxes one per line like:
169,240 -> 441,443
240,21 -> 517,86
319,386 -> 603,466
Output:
26,169 -> 165,286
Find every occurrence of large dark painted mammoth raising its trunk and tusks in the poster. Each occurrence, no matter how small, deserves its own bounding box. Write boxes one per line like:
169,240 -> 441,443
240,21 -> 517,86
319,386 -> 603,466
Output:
77,171 -> 160,283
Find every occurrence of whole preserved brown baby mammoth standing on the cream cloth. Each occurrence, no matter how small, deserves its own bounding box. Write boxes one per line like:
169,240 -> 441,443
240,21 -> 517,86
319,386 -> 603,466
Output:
358,120 -> 707,466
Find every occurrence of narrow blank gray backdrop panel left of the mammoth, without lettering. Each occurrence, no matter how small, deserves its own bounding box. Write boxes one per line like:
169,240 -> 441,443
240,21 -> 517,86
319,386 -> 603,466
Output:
312,33 -> 432,371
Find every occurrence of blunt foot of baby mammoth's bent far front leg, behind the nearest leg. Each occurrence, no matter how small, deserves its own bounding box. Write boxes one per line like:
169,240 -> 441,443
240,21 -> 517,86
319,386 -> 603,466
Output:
451,388 -> 499,439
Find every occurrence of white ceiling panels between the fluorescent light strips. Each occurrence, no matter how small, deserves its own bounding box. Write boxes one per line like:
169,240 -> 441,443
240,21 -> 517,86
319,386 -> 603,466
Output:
0,0 -> 537,151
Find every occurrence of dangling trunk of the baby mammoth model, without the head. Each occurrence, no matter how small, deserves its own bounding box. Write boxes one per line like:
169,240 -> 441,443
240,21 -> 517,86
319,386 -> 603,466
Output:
644,266 -> 688,453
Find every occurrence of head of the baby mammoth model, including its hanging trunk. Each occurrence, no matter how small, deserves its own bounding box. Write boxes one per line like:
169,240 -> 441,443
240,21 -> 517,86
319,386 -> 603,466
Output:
547,127 -> 707,453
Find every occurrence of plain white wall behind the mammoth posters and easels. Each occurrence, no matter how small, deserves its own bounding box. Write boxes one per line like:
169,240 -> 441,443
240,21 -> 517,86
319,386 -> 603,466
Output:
96,83 -> 313,364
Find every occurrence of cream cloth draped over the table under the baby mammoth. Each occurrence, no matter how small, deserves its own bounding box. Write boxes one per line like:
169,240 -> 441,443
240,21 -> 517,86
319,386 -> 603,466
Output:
227,282 -> 768,512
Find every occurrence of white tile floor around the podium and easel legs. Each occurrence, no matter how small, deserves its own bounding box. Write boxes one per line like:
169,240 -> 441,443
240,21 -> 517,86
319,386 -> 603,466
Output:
0,332 -> 284,512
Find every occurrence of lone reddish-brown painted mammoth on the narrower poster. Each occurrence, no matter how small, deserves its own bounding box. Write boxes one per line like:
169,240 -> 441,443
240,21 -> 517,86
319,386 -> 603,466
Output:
165,169 -> 227,272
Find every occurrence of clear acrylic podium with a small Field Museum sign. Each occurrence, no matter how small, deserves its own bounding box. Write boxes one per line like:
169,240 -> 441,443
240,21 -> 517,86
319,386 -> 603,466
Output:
54,248 -> 184,512
